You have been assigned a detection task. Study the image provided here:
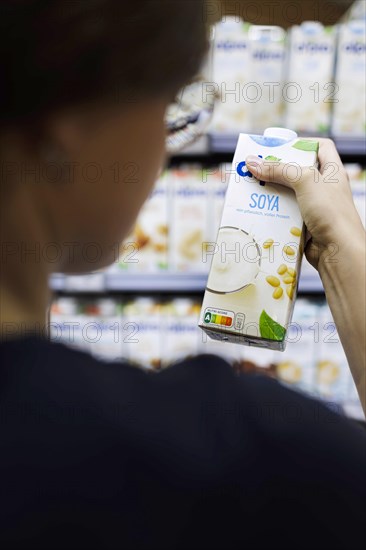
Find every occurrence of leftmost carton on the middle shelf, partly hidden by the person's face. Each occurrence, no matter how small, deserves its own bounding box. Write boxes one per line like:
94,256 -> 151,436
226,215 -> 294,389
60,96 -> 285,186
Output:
114,171 -> 169,273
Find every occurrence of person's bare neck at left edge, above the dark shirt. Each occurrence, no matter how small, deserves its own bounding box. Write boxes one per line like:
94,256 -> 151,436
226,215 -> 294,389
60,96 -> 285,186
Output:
0,153 -> 53,340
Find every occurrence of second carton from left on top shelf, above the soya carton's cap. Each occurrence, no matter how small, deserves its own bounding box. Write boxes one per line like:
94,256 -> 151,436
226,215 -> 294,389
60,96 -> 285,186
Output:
249,25 -> 286,132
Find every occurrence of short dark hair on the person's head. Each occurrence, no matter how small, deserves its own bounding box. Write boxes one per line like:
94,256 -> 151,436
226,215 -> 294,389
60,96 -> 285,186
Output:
0,0 -> 207,125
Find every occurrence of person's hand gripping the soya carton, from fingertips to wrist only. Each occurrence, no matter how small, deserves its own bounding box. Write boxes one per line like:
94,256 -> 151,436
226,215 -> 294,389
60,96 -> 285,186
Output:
246,139 -> 365,269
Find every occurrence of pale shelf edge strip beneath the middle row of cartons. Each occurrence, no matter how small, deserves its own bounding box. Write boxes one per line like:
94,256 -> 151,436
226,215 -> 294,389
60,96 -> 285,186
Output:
50,273 -> 323,293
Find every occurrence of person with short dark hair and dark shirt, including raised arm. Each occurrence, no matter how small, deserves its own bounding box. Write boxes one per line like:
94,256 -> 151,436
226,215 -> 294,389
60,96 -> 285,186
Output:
0,0 -> 366,549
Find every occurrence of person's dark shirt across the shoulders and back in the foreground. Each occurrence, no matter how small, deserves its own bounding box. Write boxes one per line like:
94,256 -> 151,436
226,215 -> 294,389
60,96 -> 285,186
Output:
0,338 -> 366,550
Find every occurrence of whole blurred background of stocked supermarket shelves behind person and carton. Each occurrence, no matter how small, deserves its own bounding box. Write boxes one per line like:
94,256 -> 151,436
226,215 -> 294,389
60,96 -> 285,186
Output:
50,0 -> 366,419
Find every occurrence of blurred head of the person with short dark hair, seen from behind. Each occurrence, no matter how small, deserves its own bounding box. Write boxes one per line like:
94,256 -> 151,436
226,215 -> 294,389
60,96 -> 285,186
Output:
0,0 -> 208,276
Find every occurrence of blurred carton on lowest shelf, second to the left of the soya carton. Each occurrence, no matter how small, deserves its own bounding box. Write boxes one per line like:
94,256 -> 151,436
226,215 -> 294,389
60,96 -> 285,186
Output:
122,298 -> 162,370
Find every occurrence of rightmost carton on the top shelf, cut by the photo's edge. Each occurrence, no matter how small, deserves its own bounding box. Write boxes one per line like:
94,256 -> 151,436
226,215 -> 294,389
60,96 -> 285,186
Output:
332,21 -> 366,137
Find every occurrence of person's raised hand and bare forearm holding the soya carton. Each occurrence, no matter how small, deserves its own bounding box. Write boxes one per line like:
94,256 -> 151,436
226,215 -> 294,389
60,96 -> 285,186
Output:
246,139 -> 366,413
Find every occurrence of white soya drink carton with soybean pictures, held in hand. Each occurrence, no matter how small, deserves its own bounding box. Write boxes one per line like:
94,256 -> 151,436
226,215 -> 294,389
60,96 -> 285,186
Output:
199,128 -> 319,351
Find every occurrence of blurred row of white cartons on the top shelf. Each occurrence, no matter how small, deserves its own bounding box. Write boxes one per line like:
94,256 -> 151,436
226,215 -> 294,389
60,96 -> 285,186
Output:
209,17 -> 366,137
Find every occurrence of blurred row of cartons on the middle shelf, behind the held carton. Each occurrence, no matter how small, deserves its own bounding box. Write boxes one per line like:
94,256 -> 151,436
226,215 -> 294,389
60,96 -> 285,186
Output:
109,164 -> 366,275
